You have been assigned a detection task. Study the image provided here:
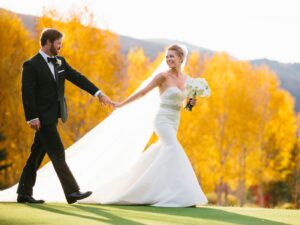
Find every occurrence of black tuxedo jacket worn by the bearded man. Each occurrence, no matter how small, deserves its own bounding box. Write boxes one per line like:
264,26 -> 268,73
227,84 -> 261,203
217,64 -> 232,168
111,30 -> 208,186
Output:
22,53 -> 99,125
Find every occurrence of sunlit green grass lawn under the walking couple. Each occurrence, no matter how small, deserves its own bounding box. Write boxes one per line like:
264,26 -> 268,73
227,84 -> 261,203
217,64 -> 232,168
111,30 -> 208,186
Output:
0,203 -> 300,225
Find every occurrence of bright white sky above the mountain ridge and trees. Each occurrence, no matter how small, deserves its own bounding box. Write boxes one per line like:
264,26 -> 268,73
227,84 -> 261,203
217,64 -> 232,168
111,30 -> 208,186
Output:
0,0 -> 300,63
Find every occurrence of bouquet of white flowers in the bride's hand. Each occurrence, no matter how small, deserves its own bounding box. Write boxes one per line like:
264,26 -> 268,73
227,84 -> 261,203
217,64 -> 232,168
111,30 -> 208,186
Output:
184,78 -> 210,111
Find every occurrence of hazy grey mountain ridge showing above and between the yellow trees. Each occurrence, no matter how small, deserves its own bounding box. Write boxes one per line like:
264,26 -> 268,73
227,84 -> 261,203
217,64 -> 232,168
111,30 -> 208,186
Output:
0,8 -> 300,112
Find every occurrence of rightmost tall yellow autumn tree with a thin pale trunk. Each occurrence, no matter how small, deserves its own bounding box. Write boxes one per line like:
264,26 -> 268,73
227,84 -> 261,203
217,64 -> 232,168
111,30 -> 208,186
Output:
252,67 -> 296,206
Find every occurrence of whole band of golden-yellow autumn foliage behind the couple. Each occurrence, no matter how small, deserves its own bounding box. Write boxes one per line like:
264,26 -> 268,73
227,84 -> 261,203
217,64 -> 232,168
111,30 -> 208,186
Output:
0,9 -> 300,207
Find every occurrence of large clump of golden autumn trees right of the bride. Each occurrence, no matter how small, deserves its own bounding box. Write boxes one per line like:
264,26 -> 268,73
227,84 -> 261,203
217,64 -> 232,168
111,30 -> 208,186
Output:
179,54 -> 295,205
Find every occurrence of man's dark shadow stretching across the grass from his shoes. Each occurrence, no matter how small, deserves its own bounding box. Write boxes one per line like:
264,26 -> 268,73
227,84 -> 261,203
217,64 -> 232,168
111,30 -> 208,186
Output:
26,204 -> 144,225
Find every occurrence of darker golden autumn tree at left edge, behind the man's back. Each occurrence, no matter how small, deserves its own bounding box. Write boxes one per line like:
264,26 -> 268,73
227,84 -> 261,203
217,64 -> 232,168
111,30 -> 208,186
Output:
0,10 -> 33,187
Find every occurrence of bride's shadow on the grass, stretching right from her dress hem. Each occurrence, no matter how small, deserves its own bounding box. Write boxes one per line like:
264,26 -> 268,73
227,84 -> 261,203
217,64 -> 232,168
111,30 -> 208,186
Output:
106,205 -> 288,225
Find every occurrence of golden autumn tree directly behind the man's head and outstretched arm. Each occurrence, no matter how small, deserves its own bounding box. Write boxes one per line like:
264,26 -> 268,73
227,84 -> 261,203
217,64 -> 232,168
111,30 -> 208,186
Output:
37,9 -> 126,146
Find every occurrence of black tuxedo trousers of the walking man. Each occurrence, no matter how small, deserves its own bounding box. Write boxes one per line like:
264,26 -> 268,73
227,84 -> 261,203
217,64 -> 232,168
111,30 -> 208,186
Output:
17,123 -> 79,196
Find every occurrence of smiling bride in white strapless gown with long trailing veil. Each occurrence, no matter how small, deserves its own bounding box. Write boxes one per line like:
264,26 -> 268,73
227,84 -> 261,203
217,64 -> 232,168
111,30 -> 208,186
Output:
0,45 -> 209,207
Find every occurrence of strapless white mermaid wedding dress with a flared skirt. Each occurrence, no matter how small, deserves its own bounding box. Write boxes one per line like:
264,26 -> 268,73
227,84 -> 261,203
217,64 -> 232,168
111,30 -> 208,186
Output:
81,87 -> 207,207
